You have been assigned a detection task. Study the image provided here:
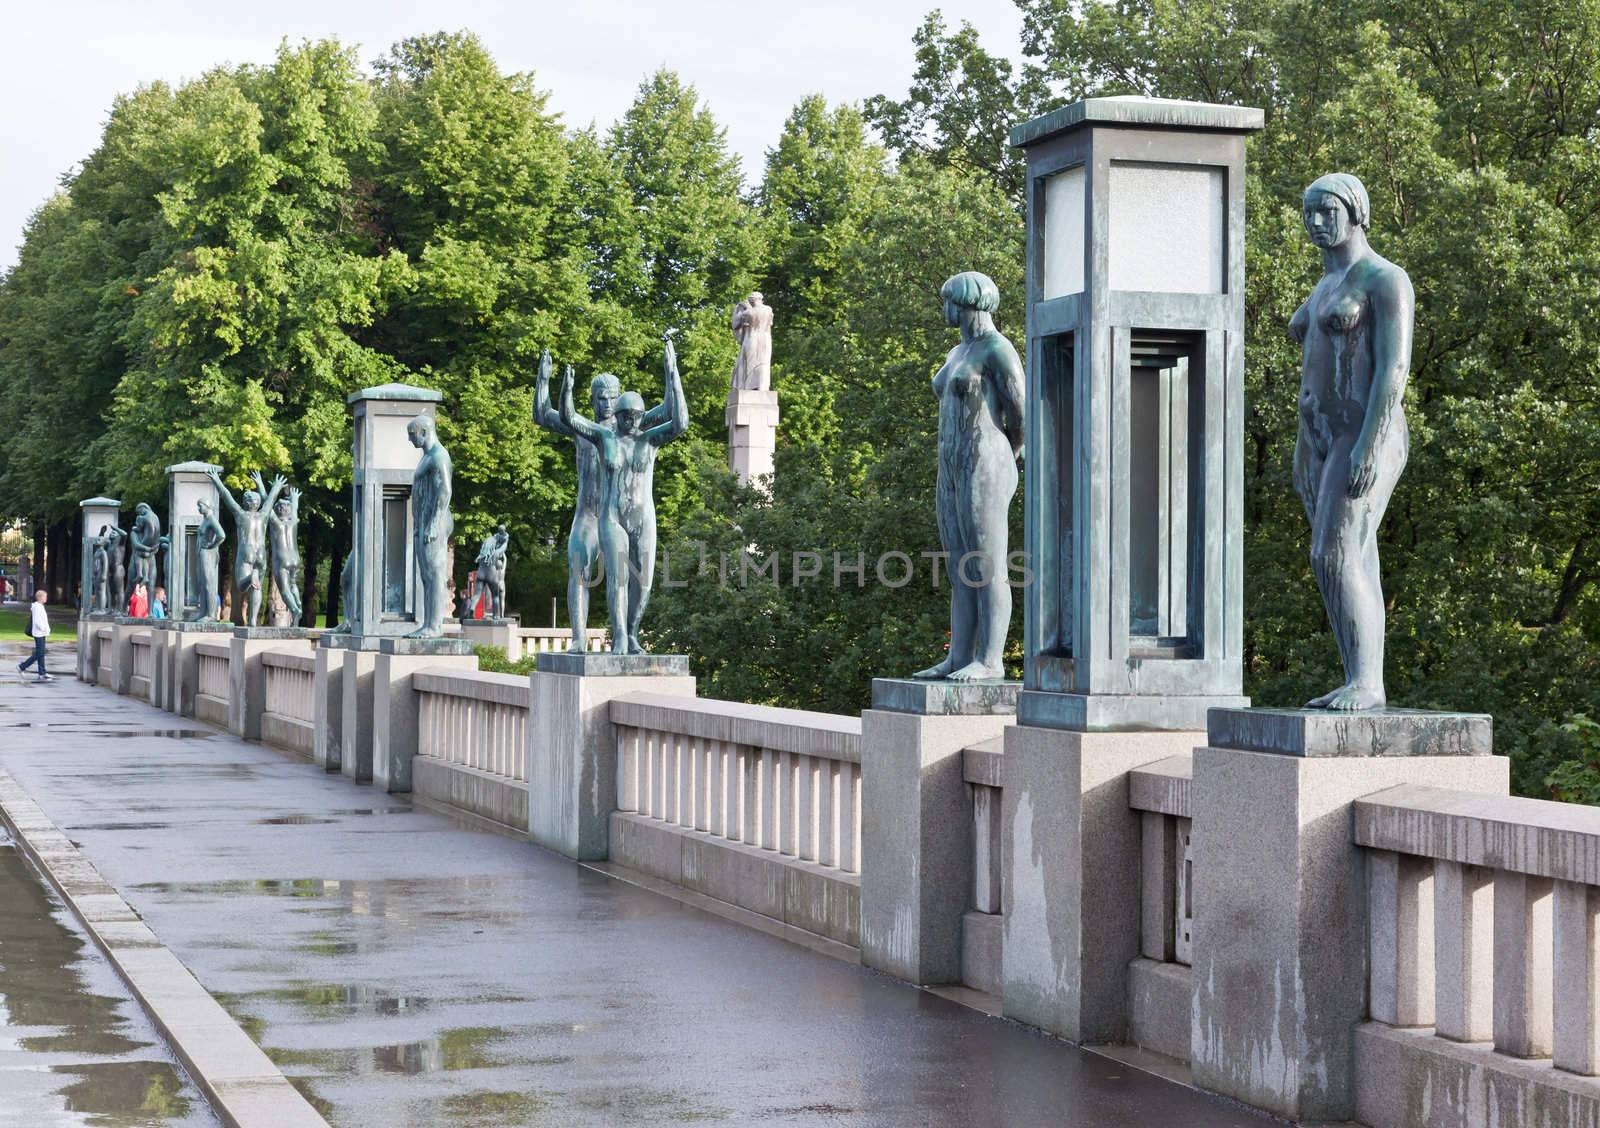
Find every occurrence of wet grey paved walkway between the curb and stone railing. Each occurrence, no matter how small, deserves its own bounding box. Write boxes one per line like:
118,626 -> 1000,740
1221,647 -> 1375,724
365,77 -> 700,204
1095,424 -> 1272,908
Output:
0,659 -> 1267,1128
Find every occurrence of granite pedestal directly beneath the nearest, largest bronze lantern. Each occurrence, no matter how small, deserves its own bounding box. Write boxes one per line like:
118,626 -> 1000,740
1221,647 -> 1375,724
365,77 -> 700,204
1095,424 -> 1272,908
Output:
1002,725 -> 1203,1042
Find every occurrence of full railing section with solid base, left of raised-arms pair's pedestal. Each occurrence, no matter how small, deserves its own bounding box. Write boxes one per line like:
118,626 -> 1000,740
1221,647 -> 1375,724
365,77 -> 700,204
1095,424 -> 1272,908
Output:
411,667 -> 531,832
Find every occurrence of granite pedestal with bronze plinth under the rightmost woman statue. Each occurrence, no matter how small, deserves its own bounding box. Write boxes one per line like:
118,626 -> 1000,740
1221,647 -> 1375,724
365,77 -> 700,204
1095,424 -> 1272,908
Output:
1190,709 -> 1509,1120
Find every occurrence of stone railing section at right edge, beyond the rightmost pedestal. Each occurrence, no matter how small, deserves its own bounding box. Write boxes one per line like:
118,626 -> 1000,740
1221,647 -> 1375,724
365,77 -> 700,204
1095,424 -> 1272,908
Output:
1355,784 -> 1600,1123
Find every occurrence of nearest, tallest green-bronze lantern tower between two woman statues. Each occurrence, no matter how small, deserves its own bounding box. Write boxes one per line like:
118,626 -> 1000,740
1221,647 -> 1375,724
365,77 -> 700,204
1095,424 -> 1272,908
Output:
1011,98 -> 1262,731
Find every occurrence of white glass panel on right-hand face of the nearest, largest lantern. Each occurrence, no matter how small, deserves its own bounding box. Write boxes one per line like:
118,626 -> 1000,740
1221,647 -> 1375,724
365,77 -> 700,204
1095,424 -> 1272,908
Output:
1113,162 -> 1227,294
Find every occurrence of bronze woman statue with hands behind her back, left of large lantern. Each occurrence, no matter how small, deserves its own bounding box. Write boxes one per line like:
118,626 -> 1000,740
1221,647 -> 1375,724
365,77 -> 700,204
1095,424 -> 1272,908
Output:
912,270 -> 1022,682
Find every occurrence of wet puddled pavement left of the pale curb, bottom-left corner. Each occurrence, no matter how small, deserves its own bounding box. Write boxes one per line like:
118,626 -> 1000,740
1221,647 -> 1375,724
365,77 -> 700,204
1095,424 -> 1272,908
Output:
0,835 -> 216,1128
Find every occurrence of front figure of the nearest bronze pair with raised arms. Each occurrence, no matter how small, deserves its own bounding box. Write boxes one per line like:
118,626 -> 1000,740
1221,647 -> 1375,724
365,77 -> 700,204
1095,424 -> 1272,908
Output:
560,341 -> 690,654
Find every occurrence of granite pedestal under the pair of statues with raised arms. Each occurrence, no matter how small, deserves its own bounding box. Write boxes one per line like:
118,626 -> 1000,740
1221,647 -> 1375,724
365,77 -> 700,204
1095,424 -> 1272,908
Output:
526,653 -> 694,861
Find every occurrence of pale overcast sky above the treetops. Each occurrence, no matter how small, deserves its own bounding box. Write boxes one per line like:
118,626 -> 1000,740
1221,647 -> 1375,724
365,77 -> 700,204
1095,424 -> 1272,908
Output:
0,0 -> 1021,270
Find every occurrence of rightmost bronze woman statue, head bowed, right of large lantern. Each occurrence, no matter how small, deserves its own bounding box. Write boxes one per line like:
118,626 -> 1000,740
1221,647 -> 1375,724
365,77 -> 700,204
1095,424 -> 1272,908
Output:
1290,173 -> 1416,710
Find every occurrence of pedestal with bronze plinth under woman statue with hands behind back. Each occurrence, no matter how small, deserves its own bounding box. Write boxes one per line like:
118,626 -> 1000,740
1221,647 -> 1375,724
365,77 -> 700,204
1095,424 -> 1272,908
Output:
861,678 -> 1021,984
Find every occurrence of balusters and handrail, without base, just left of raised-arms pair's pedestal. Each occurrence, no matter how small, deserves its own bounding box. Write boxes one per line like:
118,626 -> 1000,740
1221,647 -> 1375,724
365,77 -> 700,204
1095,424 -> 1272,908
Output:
411,670 -> 528,784
